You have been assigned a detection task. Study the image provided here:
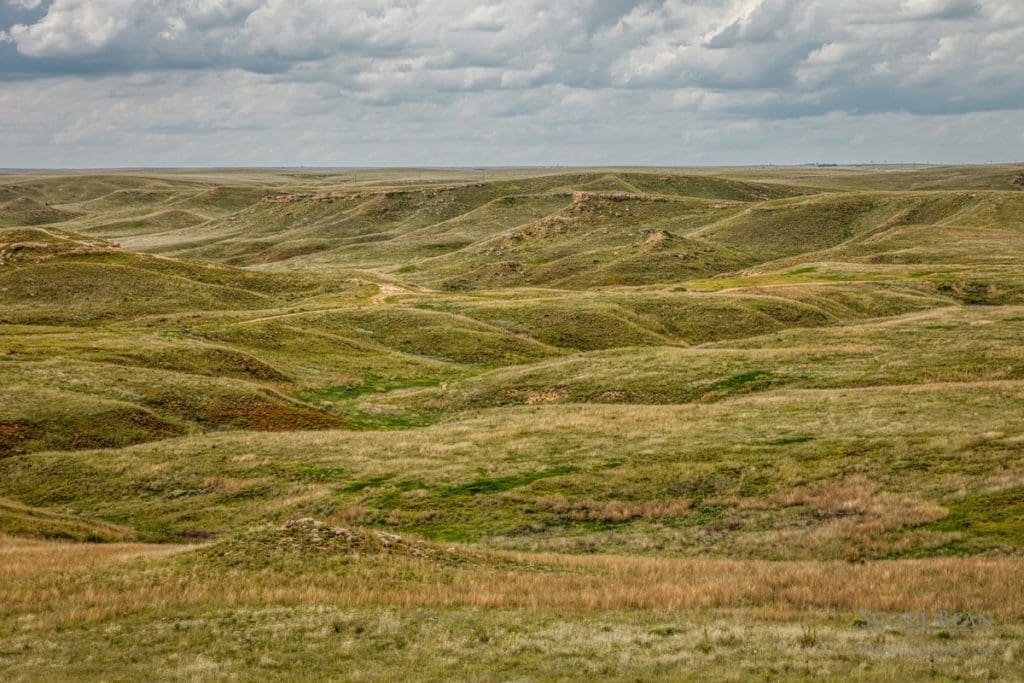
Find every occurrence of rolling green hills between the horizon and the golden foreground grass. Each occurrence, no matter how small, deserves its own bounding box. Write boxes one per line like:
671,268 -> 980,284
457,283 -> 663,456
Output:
0,169 -> 1024,559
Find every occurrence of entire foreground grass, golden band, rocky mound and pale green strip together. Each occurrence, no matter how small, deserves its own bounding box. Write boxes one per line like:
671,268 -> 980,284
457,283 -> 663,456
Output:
0,531 -> 1024,680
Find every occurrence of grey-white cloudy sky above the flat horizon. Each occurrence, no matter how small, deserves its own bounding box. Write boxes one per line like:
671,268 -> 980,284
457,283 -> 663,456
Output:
0,0 -> 1024,168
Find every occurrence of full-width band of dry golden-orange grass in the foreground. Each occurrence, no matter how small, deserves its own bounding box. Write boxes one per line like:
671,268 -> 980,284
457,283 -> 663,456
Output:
0,539 -> 1024,624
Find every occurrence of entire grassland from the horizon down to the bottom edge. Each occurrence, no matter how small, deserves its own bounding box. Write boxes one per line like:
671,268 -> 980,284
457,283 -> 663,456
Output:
0,166 -> 1024,681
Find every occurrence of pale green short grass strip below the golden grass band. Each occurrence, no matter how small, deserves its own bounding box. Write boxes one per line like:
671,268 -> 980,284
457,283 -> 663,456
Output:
8,605 -> 1022,681
